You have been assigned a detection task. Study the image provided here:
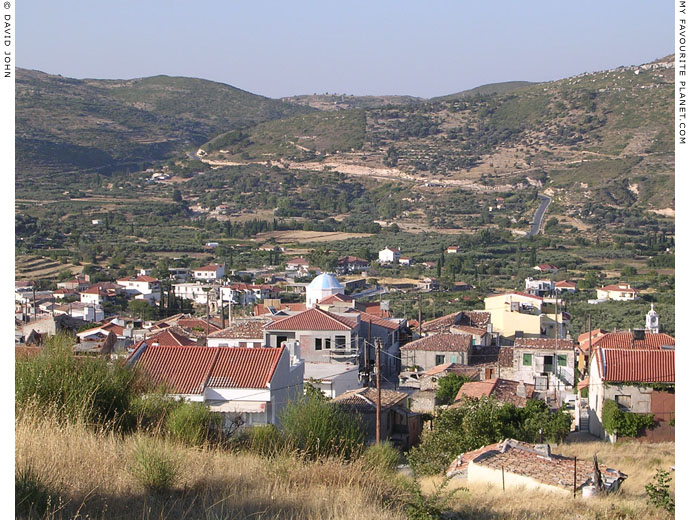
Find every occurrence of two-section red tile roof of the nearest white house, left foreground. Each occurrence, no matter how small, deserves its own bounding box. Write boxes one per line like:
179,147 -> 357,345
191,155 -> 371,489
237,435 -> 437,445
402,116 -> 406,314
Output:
137,347 -> 284,394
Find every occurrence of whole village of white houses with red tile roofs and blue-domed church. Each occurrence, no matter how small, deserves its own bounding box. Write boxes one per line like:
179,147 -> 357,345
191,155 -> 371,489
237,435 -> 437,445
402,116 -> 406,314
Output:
15,246 -> 675,496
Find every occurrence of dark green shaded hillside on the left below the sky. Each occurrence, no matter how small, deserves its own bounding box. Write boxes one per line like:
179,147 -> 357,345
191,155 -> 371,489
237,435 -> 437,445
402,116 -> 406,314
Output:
16,69 -> 312,179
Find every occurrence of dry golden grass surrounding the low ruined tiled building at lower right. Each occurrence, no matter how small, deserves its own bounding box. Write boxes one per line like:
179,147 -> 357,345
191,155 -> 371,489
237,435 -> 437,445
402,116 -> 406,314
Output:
422,442 -> 675,520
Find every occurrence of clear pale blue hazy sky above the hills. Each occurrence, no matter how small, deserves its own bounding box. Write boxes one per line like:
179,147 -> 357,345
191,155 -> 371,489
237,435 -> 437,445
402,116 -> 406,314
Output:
16,0 -> 673,97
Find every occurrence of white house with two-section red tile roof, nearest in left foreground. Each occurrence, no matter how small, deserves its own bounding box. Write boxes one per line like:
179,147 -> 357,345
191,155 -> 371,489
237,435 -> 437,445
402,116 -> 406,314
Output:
128,343 -> 304,427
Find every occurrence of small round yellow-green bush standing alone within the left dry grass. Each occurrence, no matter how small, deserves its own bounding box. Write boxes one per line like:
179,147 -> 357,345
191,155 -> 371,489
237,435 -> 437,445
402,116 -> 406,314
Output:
129,438 -> 180,493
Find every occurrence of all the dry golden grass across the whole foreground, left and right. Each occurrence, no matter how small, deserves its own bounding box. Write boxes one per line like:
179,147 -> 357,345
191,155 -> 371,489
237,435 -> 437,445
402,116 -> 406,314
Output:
15,411 -> 674,520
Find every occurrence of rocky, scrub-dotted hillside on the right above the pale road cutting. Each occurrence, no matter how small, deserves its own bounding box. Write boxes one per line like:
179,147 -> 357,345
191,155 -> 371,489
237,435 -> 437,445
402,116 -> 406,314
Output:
202,56 -> 674,212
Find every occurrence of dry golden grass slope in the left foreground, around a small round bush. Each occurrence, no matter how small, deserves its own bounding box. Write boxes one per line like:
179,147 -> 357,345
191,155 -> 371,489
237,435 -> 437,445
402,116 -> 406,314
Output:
15,413 -> 404,520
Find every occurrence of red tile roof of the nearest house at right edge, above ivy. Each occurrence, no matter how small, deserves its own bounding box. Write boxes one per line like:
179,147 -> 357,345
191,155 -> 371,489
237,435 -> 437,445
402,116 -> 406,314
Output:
594,348 -> 676,383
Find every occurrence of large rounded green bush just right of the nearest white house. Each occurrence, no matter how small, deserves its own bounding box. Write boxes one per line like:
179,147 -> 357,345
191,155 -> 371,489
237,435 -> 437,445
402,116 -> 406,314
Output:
280,397 -> 364,459
